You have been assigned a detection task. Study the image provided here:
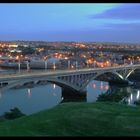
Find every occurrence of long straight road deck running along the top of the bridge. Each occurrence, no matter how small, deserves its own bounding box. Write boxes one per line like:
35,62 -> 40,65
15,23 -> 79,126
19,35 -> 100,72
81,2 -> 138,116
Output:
0,64 -> 140,82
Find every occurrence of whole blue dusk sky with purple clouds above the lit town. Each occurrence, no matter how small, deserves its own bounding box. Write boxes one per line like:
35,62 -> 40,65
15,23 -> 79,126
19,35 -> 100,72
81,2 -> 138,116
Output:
0,3 -> 140,43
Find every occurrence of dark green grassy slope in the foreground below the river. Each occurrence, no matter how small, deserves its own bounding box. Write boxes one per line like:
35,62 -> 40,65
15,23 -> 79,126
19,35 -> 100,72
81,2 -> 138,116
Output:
0,102 -> 140,136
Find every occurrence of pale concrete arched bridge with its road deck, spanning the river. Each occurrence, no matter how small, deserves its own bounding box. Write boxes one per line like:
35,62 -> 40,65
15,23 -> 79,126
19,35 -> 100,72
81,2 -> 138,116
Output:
0,64 -> 140,92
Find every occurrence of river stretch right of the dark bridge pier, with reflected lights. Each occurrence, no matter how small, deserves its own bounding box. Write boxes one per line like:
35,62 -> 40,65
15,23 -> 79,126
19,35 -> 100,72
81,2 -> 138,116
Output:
87,80 -> 140,105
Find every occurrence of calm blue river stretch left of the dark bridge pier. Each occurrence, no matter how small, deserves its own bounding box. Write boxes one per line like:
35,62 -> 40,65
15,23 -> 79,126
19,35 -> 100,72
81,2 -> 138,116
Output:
0,84 -> 62,115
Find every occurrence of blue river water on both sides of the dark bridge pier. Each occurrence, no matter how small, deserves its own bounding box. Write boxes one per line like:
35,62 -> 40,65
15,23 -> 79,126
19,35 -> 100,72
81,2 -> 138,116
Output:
0,68 -> 140,115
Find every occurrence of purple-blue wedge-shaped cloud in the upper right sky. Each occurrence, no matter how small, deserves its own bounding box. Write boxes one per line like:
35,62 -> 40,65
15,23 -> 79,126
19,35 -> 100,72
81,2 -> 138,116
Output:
90,3 -> 140,20
